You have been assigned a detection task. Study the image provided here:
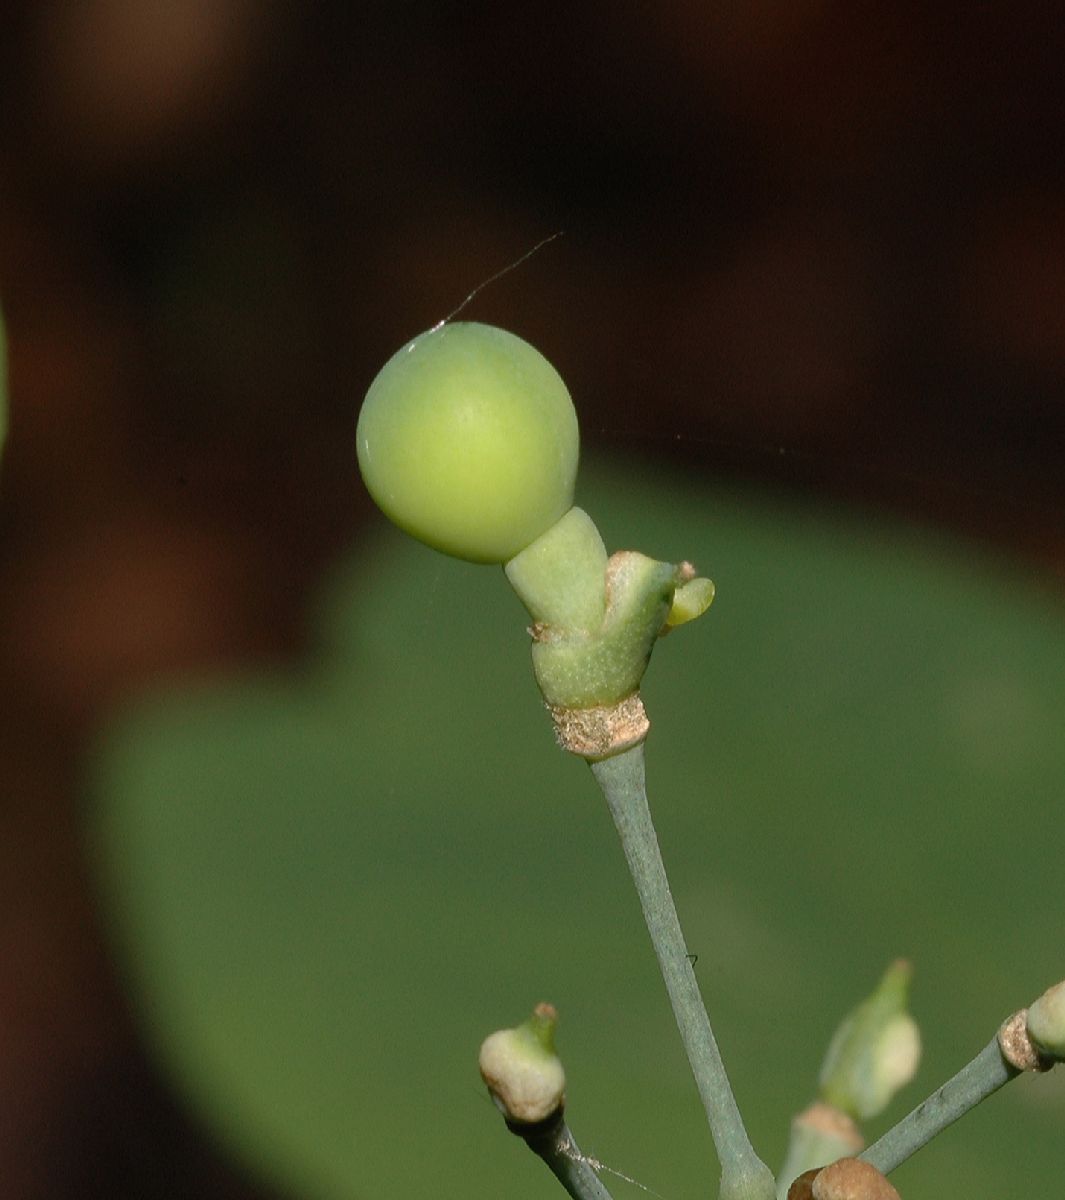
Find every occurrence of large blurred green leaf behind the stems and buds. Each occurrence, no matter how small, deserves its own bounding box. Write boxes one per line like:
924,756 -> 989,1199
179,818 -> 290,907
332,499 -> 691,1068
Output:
91,464 -> 1065,1200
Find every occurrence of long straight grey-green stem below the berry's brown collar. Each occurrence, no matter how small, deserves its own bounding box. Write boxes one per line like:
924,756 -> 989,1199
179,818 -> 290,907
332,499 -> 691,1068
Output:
591,744 -> 776,1200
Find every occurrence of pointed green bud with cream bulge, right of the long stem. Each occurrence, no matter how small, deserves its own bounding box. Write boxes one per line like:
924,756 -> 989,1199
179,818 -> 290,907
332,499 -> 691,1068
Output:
820,959 -> 921,1121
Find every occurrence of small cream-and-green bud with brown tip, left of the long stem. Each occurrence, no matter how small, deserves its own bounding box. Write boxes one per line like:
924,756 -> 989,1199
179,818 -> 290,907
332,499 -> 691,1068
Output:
479,1004 -> 566,1124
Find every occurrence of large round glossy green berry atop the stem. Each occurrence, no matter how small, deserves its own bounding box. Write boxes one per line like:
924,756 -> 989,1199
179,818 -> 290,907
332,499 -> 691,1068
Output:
356,322 -> 579,563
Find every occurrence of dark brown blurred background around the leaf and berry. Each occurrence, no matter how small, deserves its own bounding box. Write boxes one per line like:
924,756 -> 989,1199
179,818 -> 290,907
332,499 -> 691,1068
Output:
0,0 -> 1065,1200
